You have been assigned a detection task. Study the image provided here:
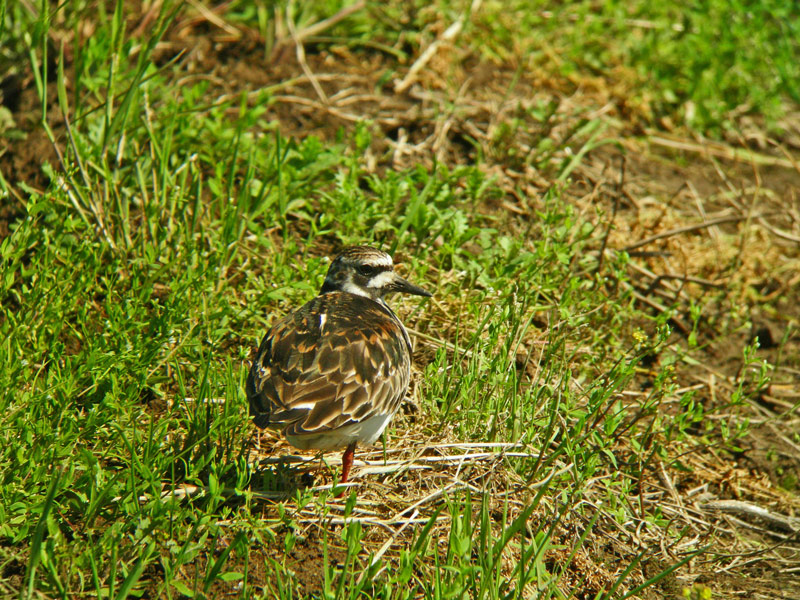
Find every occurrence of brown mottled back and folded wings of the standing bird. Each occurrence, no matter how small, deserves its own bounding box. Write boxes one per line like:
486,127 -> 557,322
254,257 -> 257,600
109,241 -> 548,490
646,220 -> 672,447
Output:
247,292 -> 411,435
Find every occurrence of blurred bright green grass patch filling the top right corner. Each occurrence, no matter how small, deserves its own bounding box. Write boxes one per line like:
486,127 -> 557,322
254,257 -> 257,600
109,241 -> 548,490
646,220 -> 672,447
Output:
476,0 -> 800,136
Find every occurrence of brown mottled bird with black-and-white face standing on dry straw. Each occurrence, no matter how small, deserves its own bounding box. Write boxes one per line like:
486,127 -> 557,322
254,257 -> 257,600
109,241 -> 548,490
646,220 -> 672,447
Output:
246,246 -> 432,497
